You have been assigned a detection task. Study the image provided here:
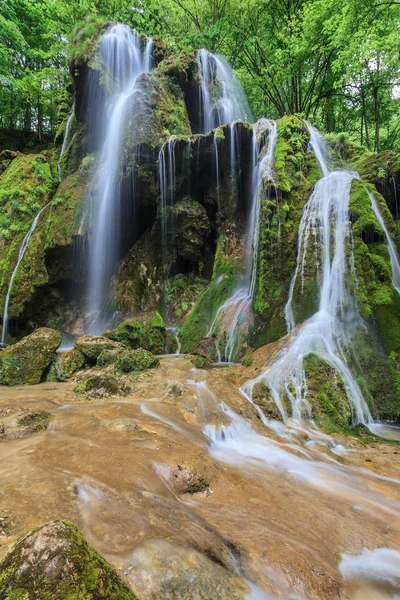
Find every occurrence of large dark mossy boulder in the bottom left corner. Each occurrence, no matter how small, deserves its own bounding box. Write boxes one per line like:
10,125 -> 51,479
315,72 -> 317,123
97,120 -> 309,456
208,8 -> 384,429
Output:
0,521 -> 137,600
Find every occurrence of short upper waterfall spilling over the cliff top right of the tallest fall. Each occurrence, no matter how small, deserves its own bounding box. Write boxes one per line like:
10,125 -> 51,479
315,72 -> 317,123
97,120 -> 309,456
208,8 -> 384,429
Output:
196,48 -> 252,133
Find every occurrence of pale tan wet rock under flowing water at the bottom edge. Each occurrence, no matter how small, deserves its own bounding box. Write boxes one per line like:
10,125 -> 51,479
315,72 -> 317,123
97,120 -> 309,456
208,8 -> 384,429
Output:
126,540 -> 250,600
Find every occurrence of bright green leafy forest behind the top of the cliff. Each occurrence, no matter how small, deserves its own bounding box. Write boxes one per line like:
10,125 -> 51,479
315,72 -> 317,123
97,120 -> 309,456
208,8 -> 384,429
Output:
0,0 -> 400,151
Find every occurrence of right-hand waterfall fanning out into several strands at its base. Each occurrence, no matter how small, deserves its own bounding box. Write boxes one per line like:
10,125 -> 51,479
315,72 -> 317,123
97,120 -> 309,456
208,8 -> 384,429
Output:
242,126 -> 372,423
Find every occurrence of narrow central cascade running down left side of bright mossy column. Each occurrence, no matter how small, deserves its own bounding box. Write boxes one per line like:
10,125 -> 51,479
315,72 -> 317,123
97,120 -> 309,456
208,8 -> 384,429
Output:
207,122 -> 277,362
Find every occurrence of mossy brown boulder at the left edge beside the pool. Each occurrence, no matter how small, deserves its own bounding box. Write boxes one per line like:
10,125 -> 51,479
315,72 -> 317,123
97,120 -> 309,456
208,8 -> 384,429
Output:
0,327 -> 61,385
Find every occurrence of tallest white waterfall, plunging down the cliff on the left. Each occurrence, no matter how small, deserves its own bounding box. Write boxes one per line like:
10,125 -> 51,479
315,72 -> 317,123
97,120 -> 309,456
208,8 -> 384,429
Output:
88,24 -> 153,333
